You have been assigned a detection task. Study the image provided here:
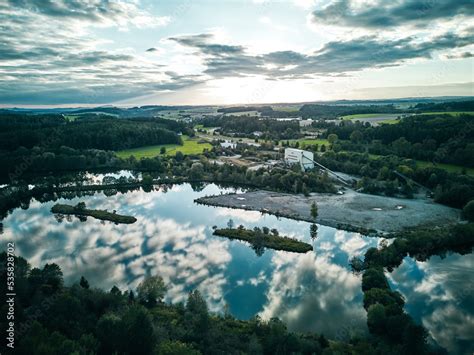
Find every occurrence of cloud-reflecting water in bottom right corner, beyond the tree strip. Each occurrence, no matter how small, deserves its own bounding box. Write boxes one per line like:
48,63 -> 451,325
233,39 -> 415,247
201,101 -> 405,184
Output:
389,254 -> 474,354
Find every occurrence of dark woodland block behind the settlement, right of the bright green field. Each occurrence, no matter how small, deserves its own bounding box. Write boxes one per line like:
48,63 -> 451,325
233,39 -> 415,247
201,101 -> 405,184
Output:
198,116 -> 300,140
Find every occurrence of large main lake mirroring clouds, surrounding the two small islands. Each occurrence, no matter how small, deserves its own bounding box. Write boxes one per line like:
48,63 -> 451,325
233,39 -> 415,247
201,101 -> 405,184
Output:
4,184 -> 377,339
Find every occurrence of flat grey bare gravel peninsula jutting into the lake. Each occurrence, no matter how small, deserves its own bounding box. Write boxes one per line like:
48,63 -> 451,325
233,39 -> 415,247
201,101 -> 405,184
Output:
197,190 -> 460,234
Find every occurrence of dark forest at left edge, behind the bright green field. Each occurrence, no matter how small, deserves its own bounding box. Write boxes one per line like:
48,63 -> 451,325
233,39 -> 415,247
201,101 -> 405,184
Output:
0,115 -> 187,152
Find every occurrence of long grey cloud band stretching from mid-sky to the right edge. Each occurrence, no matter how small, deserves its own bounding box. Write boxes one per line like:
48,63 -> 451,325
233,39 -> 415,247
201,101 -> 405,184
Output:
170,28 -> 474,79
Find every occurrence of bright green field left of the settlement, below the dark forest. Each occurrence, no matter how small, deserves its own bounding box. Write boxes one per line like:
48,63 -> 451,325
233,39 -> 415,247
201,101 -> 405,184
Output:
116,136 -> 212,159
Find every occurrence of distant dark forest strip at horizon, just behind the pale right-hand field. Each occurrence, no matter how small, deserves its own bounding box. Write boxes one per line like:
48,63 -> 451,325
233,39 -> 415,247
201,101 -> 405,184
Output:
299,104 -> 401,119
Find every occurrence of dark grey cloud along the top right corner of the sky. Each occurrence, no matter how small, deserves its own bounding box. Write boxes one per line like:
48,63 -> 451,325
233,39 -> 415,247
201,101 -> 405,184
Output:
312,0 -> 474,29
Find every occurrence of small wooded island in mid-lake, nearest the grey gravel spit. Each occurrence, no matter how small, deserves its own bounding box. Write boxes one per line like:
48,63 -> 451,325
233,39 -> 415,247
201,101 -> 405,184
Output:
214,226 -> 313,255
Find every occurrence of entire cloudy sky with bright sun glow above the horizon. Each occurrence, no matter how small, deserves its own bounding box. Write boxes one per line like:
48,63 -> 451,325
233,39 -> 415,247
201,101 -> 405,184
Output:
0,0 -> 474,107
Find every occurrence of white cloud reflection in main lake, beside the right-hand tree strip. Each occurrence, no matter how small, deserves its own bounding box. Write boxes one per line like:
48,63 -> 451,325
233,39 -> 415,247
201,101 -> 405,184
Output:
260,253 -> 367,340
